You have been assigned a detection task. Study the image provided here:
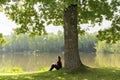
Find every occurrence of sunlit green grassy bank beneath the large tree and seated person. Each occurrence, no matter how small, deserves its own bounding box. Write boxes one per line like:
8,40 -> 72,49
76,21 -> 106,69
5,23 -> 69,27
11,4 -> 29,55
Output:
0,68 -> 120,80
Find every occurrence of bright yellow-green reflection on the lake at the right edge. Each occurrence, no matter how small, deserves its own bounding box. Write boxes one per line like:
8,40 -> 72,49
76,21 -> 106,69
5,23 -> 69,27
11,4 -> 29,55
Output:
95,53 -> 120,68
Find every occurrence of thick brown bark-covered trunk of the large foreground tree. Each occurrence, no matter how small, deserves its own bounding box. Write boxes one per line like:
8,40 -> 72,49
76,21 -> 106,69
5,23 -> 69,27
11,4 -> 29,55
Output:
64,5 -> 82,70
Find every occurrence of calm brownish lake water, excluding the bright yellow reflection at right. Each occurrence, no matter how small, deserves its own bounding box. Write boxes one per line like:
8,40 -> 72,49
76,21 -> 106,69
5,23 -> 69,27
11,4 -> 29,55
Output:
0,53 -> 96,71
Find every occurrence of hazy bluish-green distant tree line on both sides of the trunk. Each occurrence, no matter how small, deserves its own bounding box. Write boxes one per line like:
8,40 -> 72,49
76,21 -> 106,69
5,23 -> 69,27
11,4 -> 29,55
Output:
0,32 -> 97,53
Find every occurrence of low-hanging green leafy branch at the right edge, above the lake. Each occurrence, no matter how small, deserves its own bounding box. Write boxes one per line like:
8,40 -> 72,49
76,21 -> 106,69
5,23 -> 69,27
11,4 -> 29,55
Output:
97,10 -> 120,43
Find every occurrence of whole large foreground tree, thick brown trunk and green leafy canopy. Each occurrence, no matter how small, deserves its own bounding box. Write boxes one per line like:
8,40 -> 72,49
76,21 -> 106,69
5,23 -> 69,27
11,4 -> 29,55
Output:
2,0 -> 120,69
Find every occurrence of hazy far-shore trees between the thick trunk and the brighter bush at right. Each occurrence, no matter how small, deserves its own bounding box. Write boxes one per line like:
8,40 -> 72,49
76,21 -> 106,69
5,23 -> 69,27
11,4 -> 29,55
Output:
78,33 -> 98,53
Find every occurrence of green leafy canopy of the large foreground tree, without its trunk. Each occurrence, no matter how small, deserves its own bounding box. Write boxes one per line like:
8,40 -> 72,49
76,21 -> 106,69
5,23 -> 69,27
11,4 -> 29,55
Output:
2,0 -> 120,42
